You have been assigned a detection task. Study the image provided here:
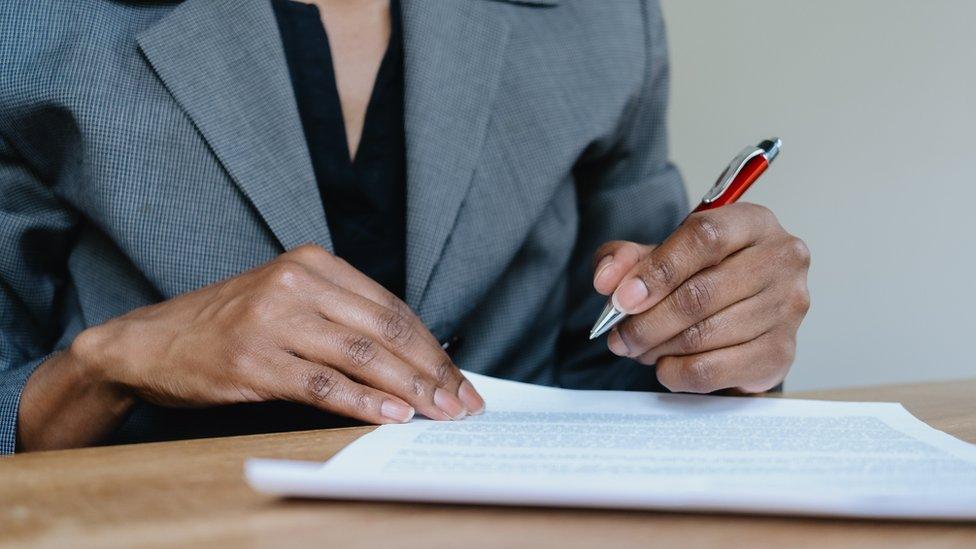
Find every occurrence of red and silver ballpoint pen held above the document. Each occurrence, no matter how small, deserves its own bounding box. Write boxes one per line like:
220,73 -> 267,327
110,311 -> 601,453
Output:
590,137 -> 783,339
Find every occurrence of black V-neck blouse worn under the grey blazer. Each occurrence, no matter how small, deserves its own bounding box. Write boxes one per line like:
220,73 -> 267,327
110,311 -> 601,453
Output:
272,0 -> 406,298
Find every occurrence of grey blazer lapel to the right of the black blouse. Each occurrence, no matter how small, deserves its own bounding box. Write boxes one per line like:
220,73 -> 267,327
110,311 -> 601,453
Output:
402,0 -> 509,310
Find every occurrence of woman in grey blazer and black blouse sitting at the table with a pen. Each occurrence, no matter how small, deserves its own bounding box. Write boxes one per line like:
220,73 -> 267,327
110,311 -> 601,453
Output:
0,0 -> 809,452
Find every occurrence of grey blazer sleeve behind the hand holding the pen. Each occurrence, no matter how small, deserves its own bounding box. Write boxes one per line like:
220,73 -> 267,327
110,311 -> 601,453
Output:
557,0 -> 688,391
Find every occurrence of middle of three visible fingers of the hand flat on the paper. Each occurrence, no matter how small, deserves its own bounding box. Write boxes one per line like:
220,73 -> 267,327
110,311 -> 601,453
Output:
281,315 -> 467,420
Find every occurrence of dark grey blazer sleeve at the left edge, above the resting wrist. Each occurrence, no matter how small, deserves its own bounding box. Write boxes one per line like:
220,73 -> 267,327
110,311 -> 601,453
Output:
0,135 -> 74,454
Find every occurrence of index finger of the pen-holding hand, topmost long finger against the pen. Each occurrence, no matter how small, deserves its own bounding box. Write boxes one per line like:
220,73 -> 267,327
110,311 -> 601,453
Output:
613,203 -> 776,315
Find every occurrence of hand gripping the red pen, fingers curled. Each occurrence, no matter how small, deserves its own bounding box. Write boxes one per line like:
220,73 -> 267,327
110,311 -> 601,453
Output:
593,203 -> 810,393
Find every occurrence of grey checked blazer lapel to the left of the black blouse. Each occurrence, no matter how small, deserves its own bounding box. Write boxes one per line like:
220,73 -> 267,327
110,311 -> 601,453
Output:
138,0 -> 332,250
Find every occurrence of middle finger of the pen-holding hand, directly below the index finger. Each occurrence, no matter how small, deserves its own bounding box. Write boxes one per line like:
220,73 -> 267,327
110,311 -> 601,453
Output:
607,246 -> 771,357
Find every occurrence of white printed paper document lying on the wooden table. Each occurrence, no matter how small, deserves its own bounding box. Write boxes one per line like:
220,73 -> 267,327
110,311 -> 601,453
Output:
245,373 -> 976,520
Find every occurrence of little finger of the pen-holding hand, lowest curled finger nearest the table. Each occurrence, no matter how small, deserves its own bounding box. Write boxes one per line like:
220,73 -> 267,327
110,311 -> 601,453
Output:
657,332 -> 796,393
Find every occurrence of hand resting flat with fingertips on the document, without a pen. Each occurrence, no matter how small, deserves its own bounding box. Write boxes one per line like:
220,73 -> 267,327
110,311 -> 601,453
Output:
22,245 -> 484,450
